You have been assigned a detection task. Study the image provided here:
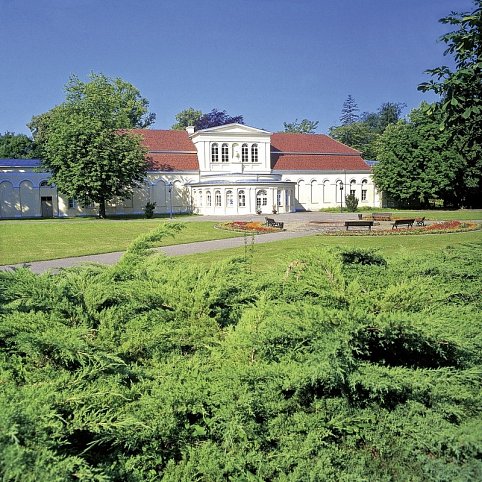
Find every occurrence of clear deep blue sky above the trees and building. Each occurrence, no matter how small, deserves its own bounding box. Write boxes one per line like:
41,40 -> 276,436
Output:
0,0 -> 473,134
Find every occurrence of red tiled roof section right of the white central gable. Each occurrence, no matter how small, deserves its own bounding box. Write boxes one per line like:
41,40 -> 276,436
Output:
271,132 -> 369,171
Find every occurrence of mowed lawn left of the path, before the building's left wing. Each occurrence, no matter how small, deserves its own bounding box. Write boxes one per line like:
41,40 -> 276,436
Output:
0,218 -> 240,265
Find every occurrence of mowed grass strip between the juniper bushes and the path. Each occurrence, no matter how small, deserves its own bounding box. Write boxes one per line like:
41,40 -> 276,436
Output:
187,230 -> 482,273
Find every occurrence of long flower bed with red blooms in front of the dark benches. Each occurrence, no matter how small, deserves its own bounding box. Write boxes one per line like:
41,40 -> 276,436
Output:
323,221 -> 482,236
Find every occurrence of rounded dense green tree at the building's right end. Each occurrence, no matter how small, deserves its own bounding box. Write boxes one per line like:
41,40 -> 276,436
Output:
373,103 -> 465,208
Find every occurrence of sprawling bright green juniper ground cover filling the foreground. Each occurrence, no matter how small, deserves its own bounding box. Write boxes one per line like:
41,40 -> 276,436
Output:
0,225 -> 482,482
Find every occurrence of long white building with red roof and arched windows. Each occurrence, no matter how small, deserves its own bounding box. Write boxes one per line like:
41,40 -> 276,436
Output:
0,124 -> 379,218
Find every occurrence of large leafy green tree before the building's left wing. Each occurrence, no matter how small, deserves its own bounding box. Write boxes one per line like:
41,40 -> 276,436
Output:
29,73 -> 155,218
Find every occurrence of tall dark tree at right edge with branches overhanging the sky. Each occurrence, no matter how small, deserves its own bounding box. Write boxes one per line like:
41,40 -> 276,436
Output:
418,0 -> 482,207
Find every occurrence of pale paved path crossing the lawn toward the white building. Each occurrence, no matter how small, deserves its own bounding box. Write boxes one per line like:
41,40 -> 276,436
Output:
0,213 -> 354,273
